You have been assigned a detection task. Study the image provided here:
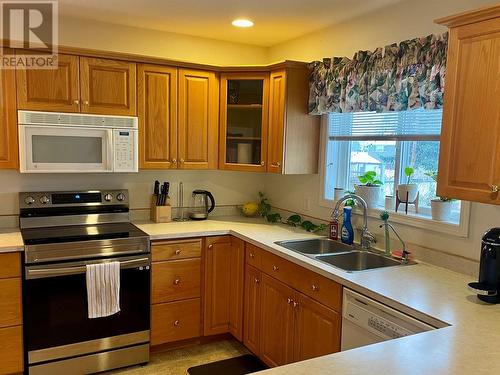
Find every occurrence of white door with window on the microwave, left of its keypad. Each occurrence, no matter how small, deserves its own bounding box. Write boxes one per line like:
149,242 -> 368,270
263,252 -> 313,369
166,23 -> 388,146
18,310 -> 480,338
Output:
19,125 -> 113,173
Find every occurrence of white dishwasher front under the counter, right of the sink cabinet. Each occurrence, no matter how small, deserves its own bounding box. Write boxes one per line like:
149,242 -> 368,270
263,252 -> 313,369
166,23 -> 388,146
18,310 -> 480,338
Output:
341,288 -> 436,350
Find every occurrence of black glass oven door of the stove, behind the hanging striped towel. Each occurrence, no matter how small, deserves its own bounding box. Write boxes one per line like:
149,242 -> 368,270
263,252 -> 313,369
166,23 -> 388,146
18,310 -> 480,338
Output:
23,254 -> 150,364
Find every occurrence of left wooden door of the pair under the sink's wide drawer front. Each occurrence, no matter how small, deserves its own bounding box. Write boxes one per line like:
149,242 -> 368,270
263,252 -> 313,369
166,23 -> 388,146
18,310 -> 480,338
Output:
259,274 -> 295,367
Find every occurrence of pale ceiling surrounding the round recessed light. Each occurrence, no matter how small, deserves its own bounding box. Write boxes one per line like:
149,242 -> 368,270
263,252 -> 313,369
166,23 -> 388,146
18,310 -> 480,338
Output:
59,0 -> 403,47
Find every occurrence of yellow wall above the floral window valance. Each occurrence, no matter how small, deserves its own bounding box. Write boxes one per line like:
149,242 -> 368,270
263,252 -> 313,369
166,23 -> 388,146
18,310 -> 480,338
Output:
269,0 -> 498,62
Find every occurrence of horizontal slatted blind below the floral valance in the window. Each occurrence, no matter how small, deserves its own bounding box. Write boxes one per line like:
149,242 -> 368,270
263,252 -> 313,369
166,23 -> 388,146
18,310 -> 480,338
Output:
328,109 -> 443,141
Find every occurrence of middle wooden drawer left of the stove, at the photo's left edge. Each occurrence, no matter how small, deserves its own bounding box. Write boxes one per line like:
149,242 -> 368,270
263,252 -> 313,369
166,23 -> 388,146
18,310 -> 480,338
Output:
0,278 -> 21,327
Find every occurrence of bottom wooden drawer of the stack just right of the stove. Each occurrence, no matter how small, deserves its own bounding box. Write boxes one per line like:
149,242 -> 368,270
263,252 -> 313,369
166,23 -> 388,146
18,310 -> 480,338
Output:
151,298 -> 201,345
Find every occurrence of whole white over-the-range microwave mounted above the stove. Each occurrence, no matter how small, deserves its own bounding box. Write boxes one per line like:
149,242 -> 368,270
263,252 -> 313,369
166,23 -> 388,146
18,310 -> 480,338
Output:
18,111 -> 138,173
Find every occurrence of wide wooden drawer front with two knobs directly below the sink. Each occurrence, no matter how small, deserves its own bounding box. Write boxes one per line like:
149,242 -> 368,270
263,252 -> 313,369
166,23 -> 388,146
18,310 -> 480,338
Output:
261,250 -> 342,311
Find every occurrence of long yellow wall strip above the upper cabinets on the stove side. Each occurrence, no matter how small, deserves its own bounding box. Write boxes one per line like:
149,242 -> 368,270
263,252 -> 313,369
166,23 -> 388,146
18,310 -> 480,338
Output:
59,17 -> 268,65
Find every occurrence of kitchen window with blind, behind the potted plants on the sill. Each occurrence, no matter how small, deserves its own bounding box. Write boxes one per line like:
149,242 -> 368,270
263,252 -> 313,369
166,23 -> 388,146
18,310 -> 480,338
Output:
322,109 -> 468,235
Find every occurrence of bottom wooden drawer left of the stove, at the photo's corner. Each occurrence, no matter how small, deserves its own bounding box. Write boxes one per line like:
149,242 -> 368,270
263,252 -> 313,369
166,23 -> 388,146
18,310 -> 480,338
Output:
0,326 -> 23,374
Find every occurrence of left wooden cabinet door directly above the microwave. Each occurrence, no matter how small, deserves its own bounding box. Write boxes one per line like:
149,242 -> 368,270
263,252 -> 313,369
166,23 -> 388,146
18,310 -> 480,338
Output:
16,55 -> 80,112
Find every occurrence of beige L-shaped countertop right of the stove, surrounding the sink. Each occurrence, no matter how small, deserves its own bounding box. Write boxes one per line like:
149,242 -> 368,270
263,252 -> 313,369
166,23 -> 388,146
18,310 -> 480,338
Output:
138,218 -> 500,375
